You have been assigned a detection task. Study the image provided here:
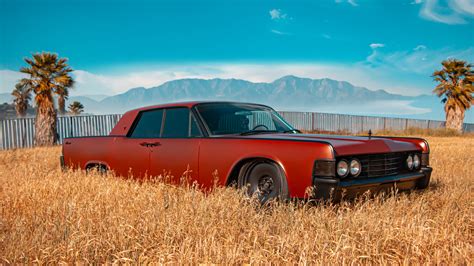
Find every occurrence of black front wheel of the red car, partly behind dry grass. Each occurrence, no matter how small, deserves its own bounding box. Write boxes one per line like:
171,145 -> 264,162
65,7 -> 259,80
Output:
238,161 -> 288,204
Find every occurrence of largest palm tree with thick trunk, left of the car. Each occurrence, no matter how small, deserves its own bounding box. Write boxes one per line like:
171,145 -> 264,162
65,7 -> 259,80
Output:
19,52 -> 73,146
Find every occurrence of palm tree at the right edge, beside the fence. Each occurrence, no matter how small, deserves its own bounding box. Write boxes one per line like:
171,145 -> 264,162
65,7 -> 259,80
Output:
433,59 -> 474,132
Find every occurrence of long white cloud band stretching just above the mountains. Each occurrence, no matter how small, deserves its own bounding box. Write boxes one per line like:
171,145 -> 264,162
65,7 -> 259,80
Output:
0,43 -> 474,96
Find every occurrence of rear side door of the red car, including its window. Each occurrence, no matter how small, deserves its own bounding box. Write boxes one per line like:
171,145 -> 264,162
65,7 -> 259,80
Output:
110,109 -> 164,178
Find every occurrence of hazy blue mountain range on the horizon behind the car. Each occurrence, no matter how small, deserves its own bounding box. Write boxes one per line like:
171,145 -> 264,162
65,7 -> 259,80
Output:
0,76 -> 460,120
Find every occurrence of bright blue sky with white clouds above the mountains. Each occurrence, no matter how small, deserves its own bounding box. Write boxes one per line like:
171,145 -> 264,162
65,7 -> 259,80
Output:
0,0 -> 474,117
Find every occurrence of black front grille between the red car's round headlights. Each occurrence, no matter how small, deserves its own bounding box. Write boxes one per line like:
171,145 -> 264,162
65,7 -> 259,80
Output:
341,152 -> 421,178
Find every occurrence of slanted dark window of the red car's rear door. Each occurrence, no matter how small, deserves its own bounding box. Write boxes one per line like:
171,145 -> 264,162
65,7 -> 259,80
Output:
130,109 -> 163,138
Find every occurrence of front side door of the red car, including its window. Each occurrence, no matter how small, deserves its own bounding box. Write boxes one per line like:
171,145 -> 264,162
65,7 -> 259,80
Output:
150,107 -> 202,184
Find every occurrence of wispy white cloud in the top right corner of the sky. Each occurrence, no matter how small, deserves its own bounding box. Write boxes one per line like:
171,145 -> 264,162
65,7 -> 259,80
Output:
412,0 -> 474,25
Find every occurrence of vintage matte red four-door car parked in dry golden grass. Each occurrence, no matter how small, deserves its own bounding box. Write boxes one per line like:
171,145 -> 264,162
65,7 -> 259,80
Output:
61,102 -> 432,202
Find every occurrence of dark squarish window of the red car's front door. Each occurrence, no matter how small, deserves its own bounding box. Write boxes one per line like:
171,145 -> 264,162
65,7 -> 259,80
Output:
162,108 -> 189,138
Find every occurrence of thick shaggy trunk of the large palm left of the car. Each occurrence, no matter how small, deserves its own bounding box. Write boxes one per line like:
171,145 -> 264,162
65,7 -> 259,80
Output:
35,105 -> 57,146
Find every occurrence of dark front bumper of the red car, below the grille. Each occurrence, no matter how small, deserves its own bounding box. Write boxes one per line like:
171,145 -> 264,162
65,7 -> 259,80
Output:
313,167 -> 432,201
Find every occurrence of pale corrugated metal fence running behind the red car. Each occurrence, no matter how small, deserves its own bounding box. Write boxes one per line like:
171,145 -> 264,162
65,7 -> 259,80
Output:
0,112 -> 474,150
